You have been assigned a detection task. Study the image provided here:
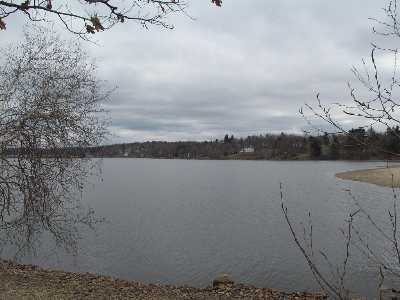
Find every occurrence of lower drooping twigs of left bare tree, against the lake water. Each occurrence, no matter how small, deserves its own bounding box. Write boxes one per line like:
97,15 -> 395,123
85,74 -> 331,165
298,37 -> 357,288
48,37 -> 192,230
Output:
0,156 -> 102,259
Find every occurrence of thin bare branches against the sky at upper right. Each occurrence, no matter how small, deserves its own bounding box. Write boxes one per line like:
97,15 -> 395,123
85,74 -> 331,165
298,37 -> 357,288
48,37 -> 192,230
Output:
300,0 -> 400,156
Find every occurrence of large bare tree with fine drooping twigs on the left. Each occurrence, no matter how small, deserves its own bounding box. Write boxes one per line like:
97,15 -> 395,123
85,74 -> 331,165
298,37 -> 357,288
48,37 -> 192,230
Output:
0,27 -> 109,258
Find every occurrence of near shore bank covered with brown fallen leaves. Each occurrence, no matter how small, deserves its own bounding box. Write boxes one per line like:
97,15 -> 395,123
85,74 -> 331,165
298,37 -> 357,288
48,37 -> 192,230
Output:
0,260 -> 326,300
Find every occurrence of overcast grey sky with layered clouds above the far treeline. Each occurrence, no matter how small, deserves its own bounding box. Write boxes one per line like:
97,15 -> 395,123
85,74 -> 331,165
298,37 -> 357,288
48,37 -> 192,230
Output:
0,0 -> 385,142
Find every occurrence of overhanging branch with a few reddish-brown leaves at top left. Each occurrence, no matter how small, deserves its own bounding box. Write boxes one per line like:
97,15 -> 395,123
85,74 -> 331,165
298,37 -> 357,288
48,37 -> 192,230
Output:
0,0 -> 222,36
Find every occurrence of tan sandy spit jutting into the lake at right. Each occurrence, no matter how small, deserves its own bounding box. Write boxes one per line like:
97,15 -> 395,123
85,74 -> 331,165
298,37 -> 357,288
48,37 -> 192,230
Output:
336,166 -> 400,187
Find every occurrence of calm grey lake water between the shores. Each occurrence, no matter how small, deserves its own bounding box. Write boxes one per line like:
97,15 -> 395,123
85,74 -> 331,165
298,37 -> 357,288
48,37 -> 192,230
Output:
7,159 -> 400,293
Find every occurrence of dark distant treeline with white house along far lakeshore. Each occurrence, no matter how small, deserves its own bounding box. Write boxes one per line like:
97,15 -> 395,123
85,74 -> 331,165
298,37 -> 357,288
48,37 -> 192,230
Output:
85,127 -> 400,160
